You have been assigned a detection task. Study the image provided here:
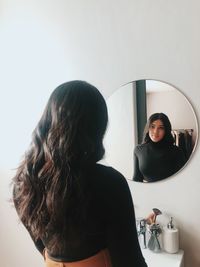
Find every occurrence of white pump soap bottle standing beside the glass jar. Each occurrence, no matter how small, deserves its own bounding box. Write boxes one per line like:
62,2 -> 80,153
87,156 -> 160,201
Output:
163,217 -> 179,253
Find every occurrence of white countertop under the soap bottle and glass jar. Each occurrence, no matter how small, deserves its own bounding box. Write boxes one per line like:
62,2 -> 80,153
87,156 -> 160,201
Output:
142,249 -> 184,267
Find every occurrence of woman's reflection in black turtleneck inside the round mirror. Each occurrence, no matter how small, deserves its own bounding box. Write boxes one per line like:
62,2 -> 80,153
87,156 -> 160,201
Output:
133,113 -> 186,182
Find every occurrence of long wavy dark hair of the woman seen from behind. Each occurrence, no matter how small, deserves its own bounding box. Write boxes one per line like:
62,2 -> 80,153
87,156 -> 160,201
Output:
13,81 -> 108,251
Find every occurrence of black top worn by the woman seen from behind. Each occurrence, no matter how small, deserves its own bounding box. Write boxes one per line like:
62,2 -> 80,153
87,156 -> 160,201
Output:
13,164 -> 147,267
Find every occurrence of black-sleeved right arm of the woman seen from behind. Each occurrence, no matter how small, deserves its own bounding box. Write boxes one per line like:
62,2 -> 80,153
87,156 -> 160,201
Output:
107,173 -> 147,267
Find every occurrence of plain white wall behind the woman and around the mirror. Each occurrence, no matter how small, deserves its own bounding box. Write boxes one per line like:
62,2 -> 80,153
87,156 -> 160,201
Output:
0,0 -> 200,267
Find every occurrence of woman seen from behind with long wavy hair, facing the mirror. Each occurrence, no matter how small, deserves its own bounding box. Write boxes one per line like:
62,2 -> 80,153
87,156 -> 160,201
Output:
13,81 -> 147,267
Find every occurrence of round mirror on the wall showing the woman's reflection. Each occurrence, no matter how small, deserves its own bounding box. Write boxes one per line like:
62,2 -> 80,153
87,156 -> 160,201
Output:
104,80 -> 198,182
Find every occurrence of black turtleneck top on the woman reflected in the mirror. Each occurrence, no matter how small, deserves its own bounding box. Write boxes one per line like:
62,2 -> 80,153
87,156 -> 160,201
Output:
133,141 -> 185,182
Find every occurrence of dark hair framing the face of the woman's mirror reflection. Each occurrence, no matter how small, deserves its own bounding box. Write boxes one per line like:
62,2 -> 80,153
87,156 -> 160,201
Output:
142,113 -> 174,145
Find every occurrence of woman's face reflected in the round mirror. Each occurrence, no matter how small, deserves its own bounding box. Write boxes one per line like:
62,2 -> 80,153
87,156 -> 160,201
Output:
149,120 -> 165,143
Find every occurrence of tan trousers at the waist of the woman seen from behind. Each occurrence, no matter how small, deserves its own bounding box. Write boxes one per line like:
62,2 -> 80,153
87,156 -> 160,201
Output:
44,249 -> 112,267
